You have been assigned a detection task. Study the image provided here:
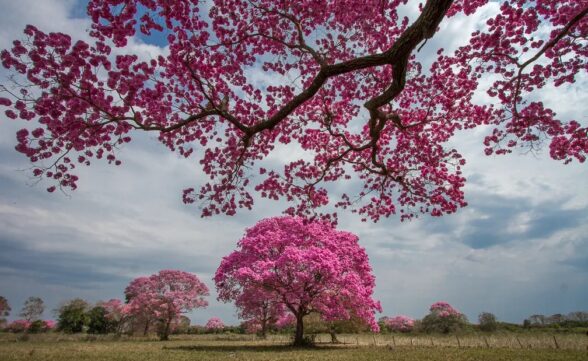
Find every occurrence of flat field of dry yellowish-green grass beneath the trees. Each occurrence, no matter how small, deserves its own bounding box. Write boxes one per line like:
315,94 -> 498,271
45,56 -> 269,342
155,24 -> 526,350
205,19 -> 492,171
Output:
0,334 -> 588,361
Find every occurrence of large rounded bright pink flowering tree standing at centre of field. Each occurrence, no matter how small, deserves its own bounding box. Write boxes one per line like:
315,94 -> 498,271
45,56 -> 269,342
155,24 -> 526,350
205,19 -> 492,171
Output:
214,216 -> 381,345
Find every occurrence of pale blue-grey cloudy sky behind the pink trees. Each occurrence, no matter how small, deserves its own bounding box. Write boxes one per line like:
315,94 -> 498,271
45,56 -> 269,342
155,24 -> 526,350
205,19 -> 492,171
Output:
0,0 -> 588,323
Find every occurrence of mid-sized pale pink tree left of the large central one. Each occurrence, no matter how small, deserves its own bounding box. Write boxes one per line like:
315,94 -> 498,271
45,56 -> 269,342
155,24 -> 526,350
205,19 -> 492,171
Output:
125,270 -> 208,340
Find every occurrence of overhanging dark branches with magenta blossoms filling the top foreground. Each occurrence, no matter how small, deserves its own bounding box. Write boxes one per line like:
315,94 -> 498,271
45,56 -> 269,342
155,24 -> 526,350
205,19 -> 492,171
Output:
0,0 -> 588,221
